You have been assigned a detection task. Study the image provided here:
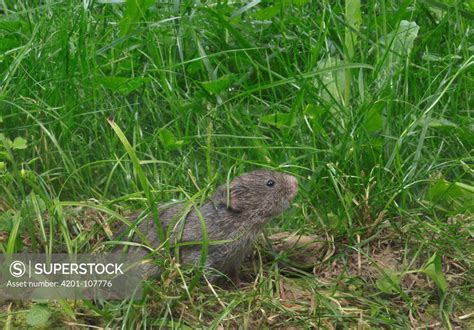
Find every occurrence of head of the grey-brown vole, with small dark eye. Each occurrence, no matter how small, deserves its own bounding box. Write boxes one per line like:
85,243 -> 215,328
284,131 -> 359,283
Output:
211,170 -> 298,221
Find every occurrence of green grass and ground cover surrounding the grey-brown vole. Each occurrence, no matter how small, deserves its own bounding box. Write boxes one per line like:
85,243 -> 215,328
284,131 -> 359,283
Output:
0,0 -> 474,328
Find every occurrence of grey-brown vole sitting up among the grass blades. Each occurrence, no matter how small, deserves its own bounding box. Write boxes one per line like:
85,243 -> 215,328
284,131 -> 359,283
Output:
122,169 -> 298,284
